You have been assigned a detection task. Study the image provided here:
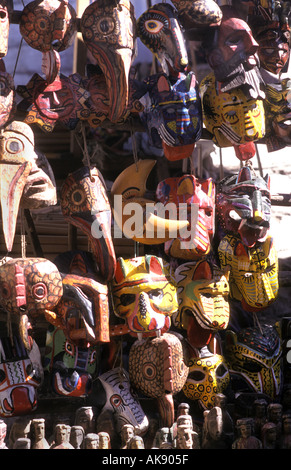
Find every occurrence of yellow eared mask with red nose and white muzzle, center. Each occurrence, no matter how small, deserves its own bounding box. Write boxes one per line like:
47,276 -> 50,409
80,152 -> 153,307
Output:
112,255 -> 178,334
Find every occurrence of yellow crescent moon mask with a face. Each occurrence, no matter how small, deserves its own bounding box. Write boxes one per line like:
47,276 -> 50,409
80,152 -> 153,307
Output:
111,160 -> 189,245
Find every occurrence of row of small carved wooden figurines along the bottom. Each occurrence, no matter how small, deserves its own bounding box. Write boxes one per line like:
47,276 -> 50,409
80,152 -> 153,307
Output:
0,394 -> 291,449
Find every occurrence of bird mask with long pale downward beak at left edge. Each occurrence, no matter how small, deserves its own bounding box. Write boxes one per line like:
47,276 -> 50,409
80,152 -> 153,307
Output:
0,121 -> 36,251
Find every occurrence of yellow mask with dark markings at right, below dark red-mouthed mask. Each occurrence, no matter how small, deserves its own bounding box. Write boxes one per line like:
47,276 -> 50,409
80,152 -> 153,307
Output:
218,235 -> 279,312
